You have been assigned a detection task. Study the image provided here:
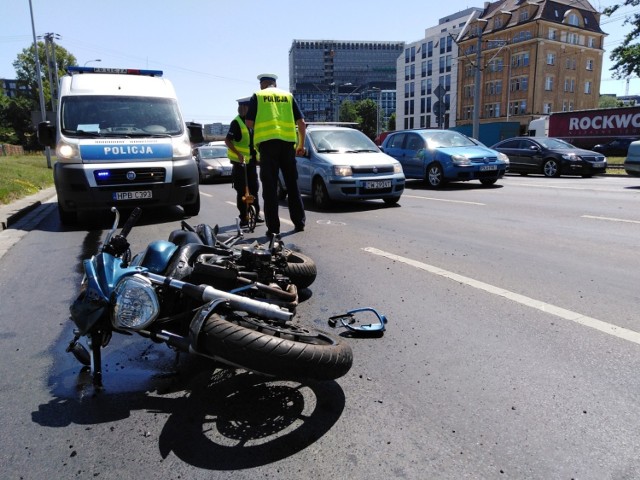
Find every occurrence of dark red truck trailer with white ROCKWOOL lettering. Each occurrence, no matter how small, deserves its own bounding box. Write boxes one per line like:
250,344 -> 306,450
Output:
529,106 -> 640,149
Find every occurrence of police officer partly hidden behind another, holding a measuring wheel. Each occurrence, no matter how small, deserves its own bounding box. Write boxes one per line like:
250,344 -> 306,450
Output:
224,97 -> 264,227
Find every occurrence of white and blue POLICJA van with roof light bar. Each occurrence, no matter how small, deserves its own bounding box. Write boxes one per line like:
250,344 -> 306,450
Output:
38,67 -> 203,225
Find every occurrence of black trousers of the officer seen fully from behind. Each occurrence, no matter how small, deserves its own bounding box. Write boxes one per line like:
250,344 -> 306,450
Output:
258,140 -> 306,233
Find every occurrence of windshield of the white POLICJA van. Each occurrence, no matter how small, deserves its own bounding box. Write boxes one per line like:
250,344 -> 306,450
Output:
60,95 -> 183,137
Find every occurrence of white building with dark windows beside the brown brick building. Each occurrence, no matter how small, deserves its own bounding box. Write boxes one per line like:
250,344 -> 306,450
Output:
396,8 -> 482,128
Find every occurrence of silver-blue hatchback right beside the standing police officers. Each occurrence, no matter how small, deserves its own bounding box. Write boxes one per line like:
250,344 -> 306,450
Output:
279,124 -> 405,208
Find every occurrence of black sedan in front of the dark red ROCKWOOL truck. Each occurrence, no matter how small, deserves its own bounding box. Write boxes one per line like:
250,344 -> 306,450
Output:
491,137 -> 607,177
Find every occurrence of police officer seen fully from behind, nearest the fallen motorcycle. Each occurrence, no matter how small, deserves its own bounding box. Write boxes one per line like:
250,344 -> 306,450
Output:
246,73 -> 307,236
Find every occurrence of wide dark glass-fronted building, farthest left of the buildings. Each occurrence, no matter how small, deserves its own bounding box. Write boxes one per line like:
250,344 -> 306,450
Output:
289,40 -> 404,123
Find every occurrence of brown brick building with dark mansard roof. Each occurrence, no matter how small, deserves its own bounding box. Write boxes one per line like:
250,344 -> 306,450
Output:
457,0 -> 606,132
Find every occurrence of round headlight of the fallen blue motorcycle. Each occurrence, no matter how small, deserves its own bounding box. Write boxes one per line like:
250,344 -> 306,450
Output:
112,275 -> 160,330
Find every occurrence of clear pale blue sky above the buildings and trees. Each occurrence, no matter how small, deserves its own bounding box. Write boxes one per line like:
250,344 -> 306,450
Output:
0,0 -> 640,124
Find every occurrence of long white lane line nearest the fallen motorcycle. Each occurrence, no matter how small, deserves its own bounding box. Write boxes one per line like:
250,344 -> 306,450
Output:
363,247 -> 640,345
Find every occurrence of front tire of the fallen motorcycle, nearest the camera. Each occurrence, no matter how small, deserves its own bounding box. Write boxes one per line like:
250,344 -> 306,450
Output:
199,309 -> 353,380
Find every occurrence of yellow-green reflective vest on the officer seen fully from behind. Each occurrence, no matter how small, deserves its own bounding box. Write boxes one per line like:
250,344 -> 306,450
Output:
253,88 -> 297,146
